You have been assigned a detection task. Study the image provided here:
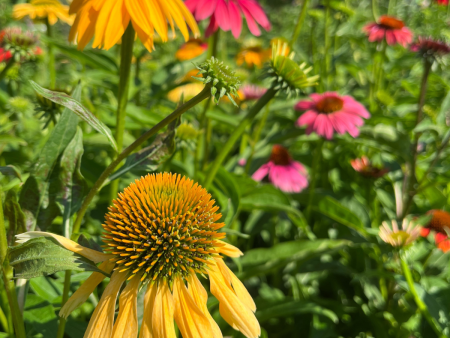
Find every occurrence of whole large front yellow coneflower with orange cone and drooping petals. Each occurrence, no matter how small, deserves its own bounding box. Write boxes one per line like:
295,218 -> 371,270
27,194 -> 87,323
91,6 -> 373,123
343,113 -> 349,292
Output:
18,173 -> 261,338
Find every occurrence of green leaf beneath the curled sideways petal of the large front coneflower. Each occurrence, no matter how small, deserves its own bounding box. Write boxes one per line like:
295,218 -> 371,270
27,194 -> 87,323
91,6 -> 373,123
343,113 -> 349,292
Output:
9,237 -> 107,279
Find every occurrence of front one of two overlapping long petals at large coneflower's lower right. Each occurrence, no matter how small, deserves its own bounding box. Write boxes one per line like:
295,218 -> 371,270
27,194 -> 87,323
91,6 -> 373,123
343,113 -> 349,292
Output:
208,263 -> 261,338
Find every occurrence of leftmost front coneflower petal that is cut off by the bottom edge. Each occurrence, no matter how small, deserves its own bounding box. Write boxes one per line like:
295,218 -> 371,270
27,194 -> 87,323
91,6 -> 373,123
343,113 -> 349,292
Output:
84,271 -> 127,338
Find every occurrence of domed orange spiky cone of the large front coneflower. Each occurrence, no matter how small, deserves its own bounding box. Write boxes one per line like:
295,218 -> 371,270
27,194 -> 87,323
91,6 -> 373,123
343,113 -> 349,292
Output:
103,173 -> 225,283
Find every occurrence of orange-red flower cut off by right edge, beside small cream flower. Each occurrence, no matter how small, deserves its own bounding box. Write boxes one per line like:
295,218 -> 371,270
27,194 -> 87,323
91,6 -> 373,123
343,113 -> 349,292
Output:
420,210 -> 450,252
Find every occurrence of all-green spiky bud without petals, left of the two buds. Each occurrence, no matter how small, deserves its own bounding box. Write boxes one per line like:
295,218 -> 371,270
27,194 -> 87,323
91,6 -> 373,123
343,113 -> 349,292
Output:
193,57 -> 241,106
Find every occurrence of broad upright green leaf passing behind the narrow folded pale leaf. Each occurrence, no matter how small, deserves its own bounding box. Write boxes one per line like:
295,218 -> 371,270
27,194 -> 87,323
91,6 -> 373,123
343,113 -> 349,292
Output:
19,86 -> 81,231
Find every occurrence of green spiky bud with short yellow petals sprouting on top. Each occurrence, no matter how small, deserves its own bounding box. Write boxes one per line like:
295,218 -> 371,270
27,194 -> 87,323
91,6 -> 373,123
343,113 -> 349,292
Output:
266,41 -> 319,95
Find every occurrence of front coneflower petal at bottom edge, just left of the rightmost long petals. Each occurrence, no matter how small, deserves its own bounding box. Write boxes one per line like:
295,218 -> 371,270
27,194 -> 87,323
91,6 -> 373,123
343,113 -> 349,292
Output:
173,277 -> 213,338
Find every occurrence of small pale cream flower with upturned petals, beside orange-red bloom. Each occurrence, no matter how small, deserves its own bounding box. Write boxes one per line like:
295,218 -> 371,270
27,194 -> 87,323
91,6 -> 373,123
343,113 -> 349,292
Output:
379,218 -> 421,247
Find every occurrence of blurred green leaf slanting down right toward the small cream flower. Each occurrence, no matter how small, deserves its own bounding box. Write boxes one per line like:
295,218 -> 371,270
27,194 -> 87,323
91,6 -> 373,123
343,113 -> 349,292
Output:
313,196 -> 367,236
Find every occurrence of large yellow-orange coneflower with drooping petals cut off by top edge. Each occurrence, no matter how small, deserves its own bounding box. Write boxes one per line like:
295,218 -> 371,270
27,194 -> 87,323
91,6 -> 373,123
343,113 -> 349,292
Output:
69,0 -> 199,51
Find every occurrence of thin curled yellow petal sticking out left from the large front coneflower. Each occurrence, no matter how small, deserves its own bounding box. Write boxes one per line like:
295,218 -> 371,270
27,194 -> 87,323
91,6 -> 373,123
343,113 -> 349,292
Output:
16,231 -> 114,263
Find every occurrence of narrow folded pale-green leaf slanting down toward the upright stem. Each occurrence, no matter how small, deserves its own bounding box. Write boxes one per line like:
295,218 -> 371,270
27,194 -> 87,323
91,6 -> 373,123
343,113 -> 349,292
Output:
30,81 -> 117,151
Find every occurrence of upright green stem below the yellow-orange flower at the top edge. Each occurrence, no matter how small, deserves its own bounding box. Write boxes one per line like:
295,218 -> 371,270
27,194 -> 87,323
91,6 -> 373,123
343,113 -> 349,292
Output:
110,23 -> 135,200
